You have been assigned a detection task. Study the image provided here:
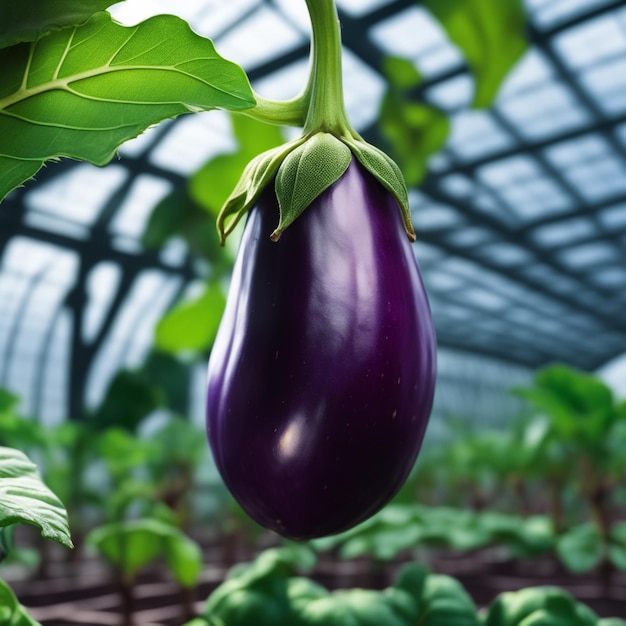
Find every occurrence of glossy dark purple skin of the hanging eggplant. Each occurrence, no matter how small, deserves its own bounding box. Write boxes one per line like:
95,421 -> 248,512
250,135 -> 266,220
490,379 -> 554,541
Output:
207,159 -> 436,540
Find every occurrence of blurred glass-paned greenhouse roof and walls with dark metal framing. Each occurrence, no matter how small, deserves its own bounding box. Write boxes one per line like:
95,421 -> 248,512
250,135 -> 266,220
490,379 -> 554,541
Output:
0,0 -> 626,422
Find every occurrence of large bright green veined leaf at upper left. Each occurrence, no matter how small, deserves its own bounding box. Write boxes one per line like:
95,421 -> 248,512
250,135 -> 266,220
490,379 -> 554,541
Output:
0,12 -> 254,197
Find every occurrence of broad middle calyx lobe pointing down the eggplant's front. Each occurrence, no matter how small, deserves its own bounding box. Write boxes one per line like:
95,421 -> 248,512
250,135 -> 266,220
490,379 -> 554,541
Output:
271,133 -> 352,241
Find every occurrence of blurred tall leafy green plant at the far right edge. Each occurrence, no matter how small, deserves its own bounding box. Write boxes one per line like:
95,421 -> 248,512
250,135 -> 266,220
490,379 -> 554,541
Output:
517,365 -> 626,585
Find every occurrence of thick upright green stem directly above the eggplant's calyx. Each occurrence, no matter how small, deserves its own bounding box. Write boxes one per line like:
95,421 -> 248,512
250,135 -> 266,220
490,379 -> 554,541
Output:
304,0 -> 358,138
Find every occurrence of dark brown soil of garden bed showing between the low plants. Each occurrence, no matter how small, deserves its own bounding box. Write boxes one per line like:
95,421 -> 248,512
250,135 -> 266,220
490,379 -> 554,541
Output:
13,550 -> 626,626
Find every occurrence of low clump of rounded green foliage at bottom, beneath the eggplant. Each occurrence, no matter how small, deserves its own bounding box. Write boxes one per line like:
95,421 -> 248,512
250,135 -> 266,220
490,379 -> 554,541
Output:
193,549 -> 478,626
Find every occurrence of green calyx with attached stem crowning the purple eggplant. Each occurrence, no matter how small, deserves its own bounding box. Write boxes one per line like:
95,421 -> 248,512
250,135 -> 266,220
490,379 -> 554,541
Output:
217,0 -> 415,243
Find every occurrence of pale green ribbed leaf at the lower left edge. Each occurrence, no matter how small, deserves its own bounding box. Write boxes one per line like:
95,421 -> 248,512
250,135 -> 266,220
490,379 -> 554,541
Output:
0,447 -> 72,548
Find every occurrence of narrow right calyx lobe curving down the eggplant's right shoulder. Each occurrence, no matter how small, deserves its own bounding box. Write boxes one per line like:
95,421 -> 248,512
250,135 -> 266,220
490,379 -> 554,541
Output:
342,139 -> 416,241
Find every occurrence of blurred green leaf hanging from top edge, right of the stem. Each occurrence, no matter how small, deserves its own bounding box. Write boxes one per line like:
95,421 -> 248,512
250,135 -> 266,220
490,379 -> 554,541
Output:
424,0 -> 528,107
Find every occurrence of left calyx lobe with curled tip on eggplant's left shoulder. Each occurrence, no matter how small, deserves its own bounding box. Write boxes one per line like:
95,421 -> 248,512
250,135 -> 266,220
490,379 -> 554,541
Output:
217,138 -> 305,244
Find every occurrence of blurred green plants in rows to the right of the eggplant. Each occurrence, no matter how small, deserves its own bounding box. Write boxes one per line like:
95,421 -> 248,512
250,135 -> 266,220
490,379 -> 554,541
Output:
318,365 -> 626,585
